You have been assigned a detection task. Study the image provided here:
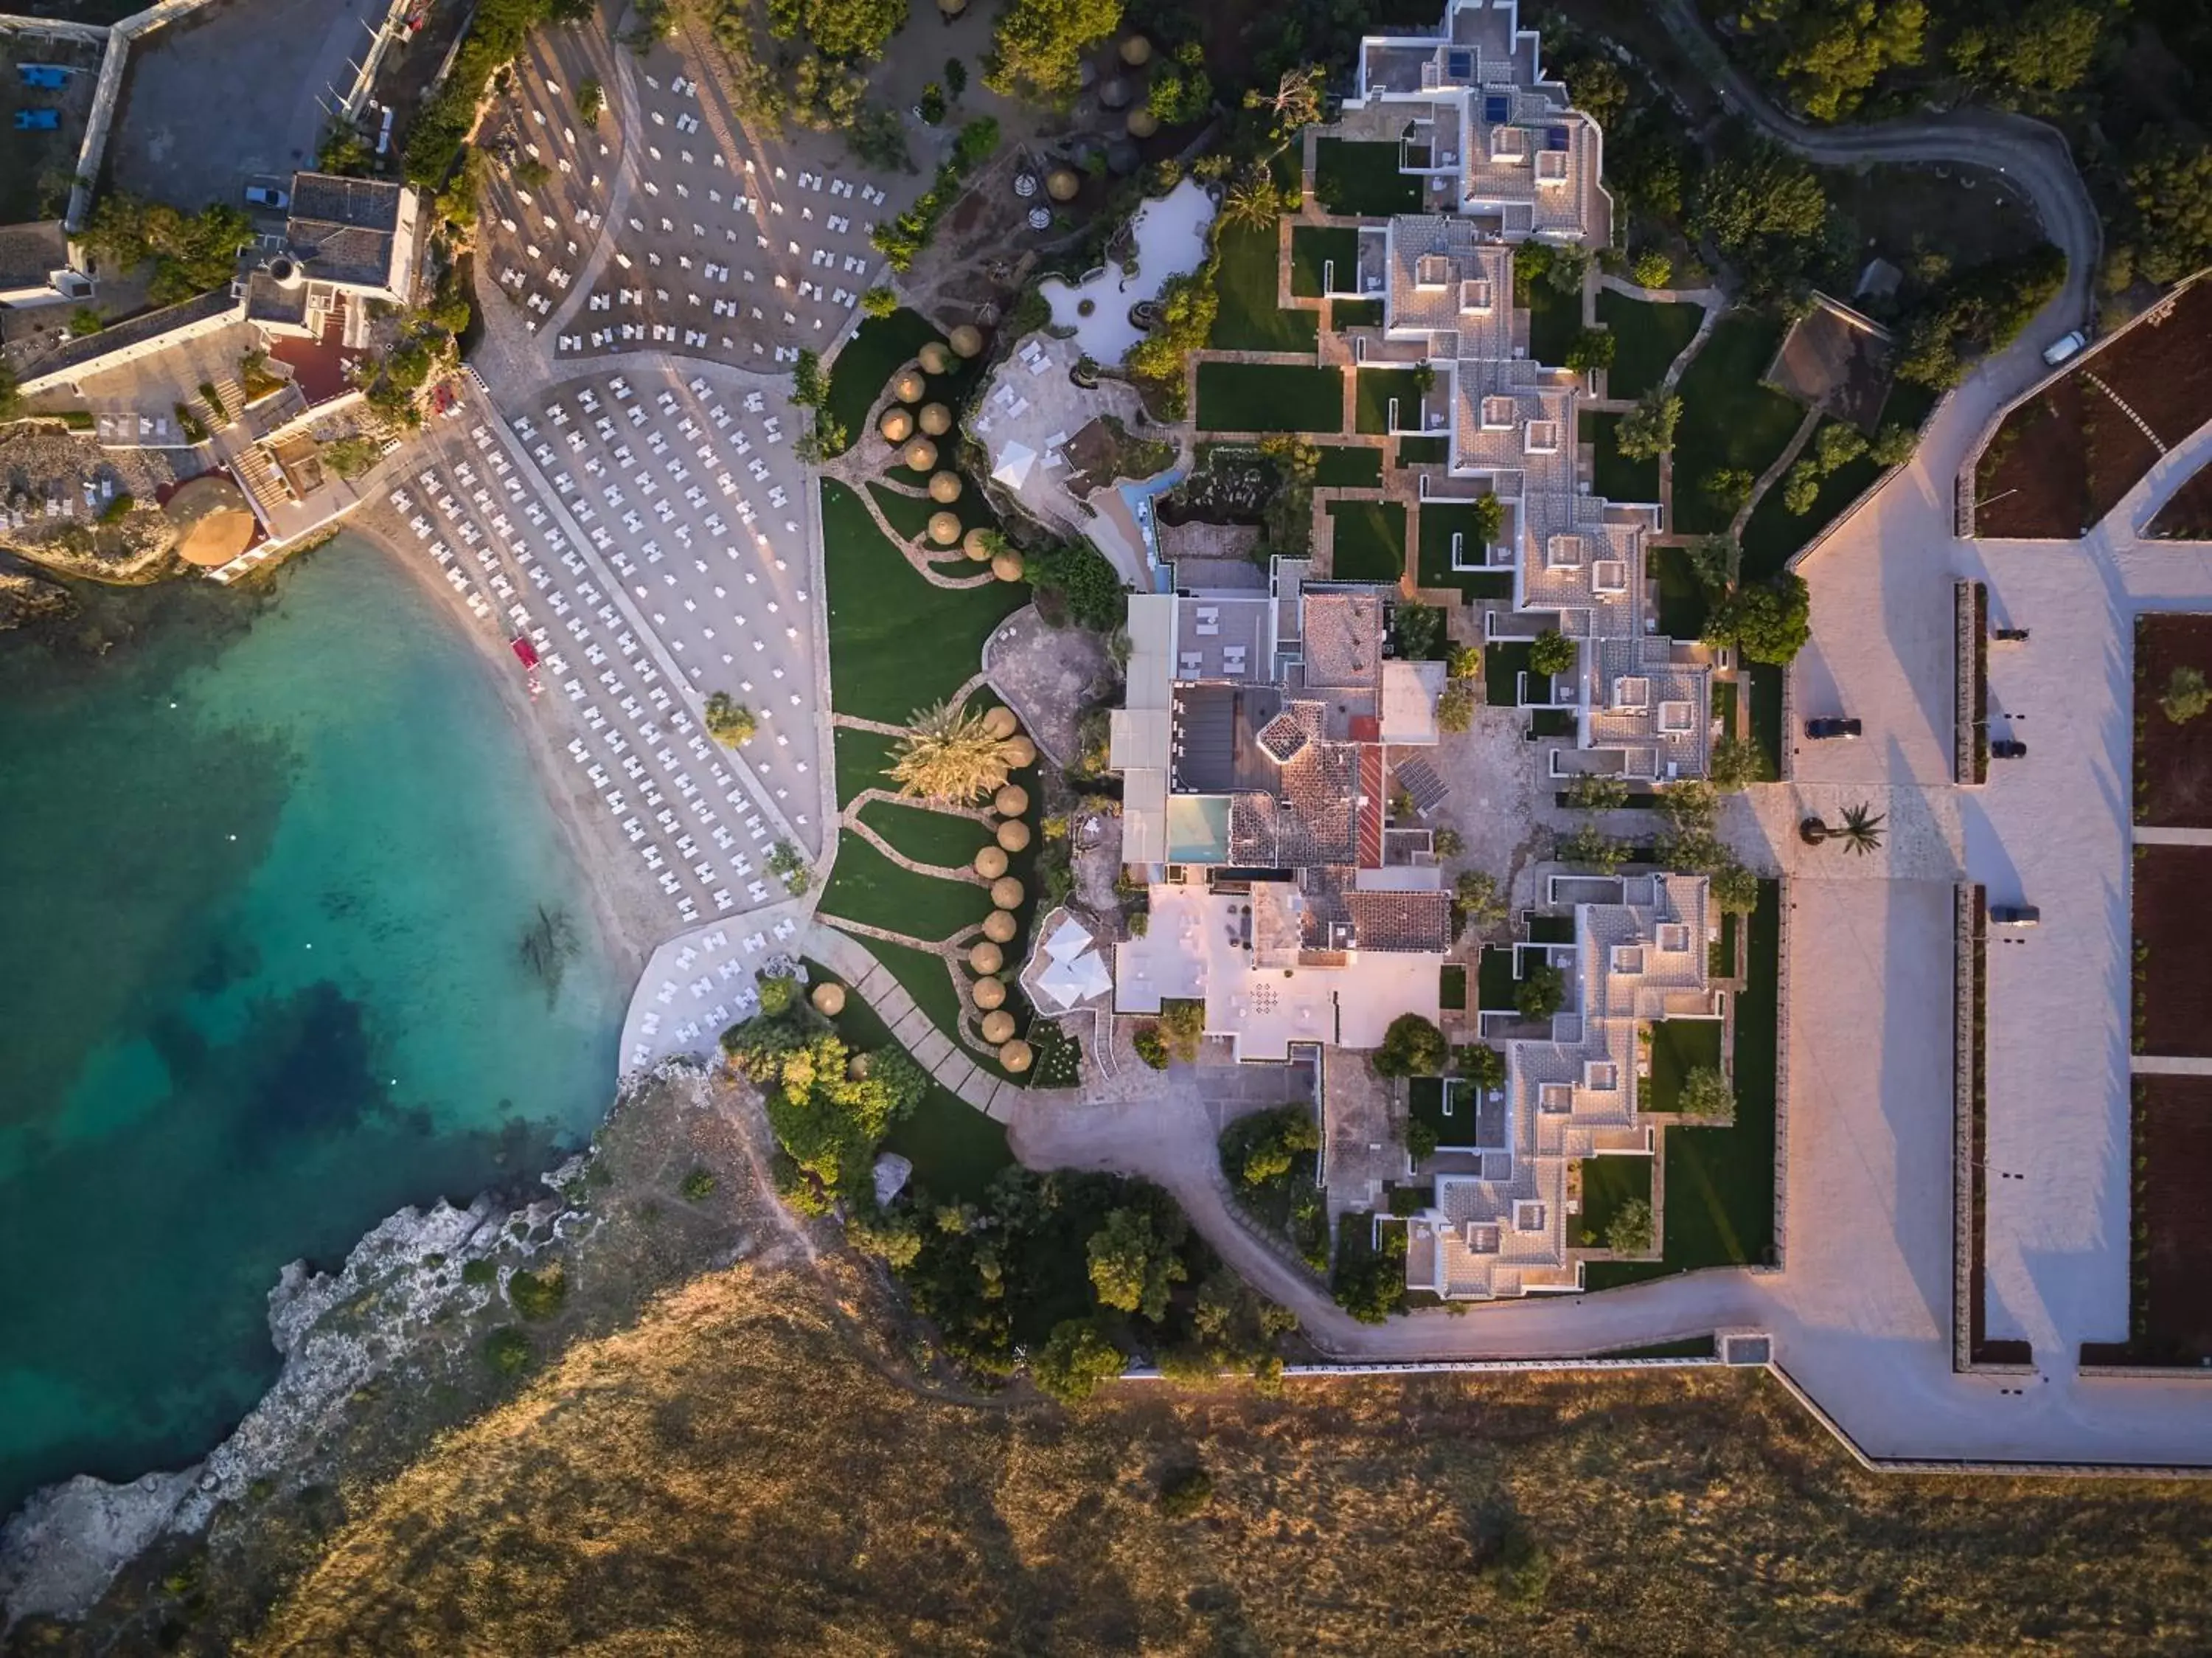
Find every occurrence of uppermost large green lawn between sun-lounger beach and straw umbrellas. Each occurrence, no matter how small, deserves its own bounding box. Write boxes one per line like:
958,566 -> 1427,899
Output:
823,480 -> 1029,724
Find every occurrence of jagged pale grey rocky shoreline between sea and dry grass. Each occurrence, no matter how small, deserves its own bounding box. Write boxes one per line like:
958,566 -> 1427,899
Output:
0,1063 -> 750,1629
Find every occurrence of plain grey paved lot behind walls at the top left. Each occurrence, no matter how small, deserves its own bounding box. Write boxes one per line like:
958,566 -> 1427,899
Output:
108,0 -> 389,212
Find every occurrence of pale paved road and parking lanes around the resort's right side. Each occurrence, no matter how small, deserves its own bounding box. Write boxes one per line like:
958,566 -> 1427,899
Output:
1011,26 -> 2212,1470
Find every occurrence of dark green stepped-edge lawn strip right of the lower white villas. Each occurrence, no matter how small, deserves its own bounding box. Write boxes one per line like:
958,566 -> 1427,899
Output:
1586,881 -> 1781,1291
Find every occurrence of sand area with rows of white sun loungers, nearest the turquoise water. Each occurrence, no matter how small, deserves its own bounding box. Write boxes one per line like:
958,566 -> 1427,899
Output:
387,356 -> 821,928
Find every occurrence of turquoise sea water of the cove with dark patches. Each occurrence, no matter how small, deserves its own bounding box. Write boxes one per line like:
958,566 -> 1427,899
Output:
0,538 -> 626,1512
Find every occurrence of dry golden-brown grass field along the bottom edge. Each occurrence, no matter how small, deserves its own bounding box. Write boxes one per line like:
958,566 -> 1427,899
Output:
211,1264 -> 2212,1658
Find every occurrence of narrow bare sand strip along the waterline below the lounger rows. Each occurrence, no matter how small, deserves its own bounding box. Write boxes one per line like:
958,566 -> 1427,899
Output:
338,498 -> 677,983
